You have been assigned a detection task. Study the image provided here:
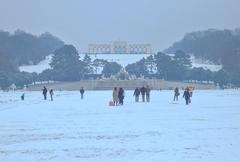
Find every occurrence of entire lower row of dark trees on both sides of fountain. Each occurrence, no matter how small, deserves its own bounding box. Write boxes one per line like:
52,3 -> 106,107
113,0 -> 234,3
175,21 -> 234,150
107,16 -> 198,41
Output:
0,45 -> 240,89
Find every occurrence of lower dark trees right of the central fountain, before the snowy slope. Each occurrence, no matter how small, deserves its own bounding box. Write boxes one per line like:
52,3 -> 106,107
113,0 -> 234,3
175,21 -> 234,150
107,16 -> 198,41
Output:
125,50 -> 232,88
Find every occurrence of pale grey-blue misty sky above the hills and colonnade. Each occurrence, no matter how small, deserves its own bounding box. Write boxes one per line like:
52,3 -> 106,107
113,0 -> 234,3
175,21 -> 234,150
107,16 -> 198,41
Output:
0,0 -> 240,52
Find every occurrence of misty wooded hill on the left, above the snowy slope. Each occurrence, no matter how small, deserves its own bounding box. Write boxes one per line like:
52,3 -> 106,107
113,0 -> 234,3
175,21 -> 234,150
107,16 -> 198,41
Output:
0,30 -> 64,66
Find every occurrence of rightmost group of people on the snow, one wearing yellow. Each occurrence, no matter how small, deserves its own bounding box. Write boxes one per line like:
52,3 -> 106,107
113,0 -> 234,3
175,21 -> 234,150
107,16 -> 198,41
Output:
173,87 -> 194,105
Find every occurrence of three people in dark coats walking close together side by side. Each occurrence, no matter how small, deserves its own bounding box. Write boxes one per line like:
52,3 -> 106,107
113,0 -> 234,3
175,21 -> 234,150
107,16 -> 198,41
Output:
133,85 -> 151,102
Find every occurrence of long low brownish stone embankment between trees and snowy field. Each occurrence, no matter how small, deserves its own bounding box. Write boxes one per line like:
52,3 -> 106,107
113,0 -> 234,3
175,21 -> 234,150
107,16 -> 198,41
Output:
28,79 -> 217,91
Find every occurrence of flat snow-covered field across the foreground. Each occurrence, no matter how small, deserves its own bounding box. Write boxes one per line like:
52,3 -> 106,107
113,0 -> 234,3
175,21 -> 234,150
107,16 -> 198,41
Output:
0,90 -> 240,162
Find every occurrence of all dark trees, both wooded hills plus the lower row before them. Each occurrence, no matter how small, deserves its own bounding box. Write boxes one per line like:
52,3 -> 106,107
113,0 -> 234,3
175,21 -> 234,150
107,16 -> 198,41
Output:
0,30 -> 240,89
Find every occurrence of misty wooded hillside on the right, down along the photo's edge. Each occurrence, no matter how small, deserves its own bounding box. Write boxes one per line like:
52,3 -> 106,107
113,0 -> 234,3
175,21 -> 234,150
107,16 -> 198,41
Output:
166,29 -> 240,86
